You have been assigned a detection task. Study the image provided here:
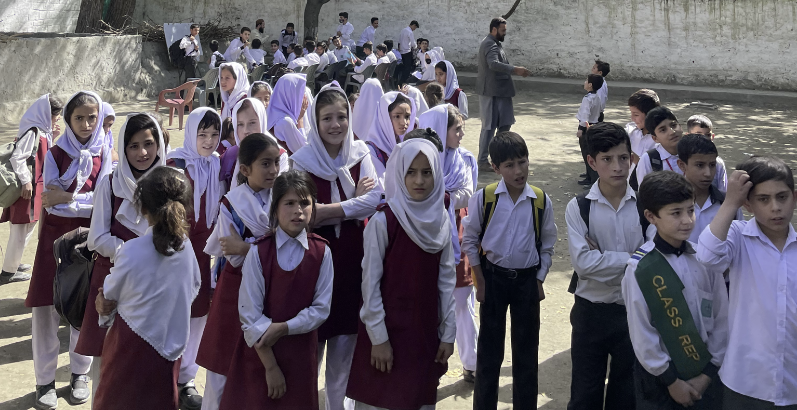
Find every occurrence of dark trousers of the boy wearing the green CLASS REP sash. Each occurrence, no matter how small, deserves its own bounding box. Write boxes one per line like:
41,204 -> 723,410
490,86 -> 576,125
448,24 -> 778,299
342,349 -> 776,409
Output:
634,359 -> 720,410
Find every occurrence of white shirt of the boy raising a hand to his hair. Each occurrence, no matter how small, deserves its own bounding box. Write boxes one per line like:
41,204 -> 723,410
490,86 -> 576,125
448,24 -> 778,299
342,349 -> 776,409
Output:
697,218 -> 797,406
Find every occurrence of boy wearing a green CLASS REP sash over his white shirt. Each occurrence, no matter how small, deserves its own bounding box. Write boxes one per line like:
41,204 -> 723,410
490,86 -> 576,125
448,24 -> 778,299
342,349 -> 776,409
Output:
622,171 -> 728,410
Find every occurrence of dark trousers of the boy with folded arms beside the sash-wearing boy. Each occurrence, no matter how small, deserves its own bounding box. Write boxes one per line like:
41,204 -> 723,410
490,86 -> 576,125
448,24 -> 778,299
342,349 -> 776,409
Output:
567,296 -> 635,410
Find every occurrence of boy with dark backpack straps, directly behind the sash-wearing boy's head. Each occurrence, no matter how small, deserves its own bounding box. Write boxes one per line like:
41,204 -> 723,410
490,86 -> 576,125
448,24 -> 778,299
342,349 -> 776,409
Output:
636,106 -> 684,186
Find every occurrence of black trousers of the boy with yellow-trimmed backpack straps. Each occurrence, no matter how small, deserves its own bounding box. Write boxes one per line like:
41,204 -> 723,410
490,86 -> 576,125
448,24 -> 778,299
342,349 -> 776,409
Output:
473,264 -> 540,410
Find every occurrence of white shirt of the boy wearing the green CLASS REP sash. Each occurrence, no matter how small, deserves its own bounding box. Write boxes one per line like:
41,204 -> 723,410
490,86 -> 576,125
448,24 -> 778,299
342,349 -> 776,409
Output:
622,236 -> 728,382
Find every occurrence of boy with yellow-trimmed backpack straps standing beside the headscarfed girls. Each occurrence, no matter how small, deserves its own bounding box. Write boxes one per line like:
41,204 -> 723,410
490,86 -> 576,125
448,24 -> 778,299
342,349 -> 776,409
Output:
462,132 -> 556,409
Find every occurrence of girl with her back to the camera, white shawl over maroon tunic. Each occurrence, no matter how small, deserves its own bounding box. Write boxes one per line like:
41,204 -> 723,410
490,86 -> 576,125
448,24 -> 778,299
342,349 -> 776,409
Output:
88,167 -> 201,410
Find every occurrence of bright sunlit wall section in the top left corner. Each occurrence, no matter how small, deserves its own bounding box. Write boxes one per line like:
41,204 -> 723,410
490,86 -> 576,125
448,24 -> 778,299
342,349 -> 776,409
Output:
0,0 -> 80,33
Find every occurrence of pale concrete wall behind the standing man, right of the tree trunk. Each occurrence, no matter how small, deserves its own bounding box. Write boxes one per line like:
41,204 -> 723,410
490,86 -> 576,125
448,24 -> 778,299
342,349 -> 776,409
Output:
319,0 -> 797,90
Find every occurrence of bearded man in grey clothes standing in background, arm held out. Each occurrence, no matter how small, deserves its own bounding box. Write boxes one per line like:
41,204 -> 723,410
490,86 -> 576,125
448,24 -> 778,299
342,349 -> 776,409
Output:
476,17 -> 531,168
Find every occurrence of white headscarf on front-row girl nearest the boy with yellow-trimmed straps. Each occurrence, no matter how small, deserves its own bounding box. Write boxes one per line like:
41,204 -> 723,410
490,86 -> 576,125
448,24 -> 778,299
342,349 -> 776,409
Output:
385,138 -> 451,253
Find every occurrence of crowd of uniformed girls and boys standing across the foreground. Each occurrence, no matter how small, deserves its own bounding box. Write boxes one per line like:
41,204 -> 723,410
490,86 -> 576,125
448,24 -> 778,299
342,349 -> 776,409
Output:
0,16 -> 797,409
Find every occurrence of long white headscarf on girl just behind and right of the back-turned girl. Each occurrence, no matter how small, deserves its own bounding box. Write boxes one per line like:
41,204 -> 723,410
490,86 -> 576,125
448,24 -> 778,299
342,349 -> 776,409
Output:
167,104 -> 221,228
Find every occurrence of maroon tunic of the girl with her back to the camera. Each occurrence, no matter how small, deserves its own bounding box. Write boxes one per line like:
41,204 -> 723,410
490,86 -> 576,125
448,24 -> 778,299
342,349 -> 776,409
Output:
92,316 -> 180,410
